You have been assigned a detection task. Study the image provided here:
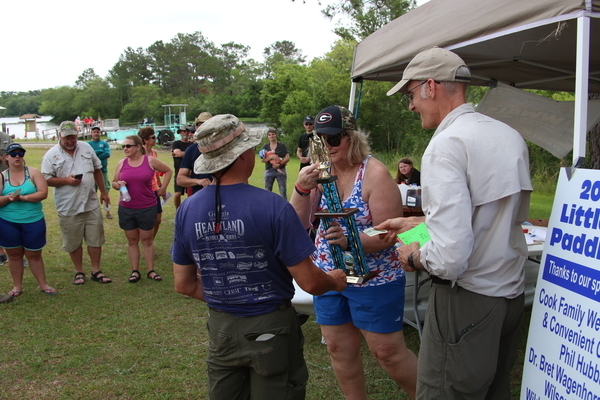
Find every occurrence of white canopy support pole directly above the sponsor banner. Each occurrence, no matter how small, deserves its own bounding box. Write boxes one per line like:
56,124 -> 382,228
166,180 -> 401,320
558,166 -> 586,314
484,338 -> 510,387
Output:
573,16 -> 590,165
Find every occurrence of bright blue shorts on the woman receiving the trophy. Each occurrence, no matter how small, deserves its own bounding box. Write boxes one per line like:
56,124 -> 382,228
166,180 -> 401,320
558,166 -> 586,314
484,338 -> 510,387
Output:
313,277 -> 406,333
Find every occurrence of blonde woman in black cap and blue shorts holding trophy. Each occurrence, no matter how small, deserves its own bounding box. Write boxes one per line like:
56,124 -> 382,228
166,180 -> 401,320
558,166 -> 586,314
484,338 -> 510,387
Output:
290,106 -> 417,399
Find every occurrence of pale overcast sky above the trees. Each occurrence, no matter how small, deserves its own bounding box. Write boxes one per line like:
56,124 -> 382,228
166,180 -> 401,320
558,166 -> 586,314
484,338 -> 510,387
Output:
0,0 -> 427,92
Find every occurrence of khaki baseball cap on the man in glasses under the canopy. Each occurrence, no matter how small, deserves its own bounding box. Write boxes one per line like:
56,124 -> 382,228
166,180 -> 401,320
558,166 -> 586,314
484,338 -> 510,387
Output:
387,47 -> 471,96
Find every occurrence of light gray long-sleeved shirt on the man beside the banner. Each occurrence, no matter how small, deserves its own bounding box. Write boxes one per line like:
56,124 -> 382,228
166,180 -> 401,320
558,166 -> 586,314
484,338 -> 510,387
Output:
421,104 -> 532,298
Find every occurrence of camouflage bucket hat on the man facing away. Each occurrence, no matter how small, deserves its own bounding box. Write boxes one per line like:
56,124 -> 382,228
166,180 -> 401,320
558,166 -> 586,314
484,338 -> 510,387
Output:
194,114 -> 263,174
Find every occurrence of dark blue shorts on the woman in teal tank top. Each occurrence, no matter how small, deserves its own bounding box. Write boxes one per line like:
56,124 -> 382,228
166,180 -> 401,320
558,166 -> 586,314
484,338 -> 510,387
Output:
0,218 -> 46,251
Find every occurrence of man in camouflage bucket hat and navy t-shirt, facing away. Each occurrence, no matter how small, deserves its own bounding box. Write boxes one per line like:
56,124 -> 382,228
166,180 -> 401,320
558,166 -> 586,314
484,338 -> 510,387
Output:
171,114 -> 346,400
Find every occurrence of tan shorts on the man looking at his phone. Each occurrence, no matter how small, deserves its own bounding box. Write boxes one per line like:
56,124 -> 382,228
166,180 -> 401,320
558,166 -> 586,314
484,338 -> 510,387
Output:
58,207 -> 105,253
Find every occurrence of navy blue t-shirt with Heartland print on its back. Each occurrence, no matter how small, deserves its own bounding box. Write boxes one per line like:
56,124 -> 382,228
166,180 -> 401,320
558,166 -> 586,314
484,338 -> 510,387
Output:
171,183 -> 315,317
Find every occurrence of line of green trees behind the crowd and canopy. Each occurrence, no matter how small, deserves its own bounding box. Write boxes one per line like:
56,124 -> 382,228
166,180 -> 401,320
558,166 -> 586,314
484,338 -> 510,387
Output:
0,0 -> 576,171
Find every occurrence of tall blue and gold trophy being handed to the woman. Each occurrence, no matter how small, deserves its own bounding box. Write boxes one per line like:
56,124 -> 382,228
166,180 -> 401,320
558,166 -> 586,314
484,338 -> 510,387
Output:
309,111 -> 377,284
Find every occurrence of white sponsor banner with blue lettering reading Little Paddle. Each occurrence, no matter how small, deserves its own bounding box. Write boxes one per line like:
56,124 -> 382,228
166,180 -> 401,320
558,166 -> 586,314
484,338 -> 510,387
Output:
521,168 -> 600,400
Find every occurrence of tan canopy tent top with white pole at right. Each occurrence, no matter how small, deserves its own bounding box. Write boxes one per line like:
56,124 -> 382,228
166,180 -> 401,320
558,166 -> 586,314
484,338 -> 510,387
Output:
350,0 -> 600,161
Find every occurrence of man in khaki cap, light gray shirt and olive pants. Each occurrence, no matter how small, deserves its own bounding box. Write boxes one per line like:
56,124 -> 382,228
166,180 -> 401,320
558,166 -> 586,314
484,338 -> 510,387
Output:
375,47 -> 532,399
